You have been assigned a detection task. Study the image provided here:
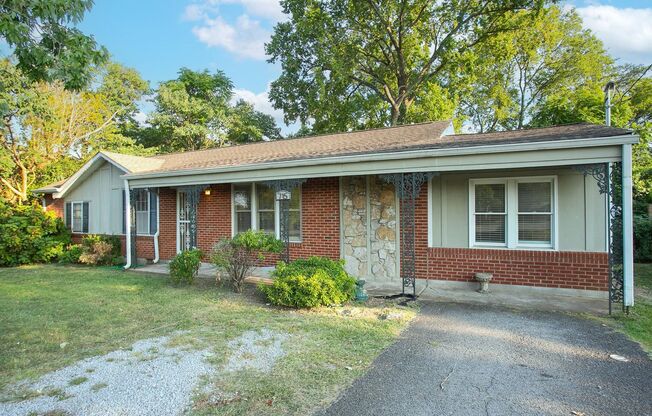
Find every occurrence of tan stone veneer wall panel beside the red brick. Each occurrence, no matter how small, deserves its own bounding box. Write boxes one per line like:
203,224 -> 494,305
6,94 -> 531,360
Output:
342,176 -> 398,279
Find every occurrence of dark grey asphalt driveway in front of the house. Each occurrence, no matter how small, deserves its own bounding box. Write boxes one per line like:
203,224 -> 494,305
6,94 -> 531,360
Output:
323,303 -> 652,416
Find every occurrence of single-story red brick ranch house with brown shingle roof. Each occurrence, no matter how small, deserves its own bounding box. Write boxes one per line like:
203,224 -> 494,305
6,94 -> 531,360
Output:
37,121 -> 638,305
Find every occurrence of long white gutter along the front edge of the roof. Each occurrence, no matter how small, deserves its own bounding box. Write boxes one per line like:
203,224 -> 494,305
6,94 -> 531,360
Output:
121,134 -> 639,179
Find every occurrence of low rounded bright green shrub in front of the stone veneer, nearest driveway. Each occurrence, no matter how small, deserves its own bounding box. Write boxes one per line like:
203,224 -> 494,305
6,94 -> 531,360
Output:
260,257 -> 355,308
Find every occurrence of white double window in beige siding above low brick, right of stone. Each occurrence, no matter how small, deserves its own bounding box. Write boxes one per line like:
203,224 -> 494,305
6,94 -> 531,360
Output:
469,177 -> 555,248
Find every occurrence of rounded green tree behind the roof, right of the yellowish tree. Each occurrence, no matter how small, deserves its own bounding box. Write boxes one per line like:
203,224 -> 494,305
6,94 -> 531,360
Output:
147,68 -> 233,151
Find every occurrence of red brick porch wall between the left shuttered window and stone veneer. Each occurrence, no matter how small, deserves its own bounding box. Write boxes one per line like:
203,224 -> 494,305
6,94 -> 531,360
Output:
159,178 -> 340,264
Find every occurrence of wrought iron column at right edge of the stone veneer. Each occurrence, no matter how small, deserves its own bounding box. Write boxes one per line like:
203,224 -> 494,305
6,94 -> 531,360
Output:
380,172 -> 434,297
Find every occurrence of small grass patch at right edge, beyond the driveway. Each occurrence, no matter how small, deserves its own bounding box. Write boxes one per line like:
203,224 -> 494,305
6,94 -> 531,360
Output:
603,263 -> 652,355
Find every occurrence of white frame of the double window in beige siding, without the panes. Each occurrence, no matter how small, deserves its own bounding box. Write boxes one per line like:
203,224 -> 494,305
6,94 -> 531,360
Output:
469,175 -> 559,250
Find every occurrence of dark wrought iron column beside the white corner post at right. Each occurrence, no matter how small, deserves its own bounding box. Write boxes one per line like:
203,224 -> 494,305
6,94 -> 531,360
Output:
576,163 -> 625,314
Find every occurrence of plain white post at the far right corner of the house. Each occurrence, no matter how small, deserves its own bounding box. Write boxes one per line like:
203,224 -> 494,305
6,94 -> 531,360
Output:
622,144 -> 634,306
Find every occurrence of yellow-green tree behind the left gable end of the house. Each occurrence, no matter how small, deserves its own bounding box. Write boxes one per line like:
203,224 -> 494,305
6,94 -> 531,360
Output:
0,59 -> 147,203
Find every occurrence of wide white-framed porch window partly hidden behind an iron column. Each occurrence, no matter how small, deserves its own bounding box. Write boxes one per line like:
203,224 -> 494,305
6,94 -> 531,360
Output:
233,183 -> 301,241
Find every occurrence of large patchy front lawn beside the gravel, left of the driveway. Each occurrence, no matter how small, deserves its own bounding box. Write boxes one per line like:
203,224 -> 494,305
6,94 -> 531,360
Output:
0,266 -> 415,414
